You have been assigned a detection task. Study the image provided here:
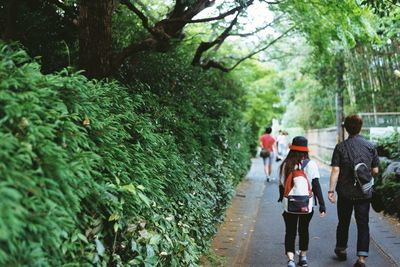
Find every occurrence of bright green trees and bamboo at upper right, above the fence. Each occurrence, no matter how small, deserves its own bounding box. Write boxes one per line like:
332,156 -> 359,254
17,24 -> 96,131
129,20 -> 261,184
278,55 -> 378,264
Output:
275,0 -> 400,129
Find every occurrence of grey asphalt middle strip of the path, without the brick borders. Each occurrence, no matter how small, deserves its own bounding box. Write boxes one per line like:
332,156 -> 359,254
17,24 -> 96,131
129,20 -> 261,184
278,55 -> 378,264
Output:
241,159 -> 398,267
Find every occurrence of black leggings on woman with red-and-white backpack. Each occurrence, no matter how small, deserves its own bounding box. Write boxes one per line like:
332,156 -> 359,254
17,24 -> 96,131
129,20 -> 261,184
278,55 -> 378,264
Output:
282,211 -> 314,253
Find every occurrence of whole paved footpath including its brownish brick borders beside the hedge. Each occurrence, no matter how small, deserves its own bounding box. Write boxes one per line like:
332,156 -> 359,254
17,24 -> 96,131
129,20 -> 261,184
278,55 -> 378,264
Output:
212,158 -> 400,267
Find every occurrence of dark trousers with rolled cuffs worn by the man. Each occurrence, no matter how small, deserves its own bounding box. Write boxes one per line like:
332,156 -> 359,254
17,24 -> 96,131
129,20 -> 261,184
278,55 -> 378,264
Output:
336,195 -> 370,257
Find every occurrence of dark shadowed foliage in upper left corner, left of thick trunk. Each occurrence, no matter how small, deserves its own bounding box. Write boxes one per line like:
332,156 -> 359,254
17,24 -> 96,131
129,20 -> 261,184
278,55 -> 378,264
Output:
0,0 -> 79,73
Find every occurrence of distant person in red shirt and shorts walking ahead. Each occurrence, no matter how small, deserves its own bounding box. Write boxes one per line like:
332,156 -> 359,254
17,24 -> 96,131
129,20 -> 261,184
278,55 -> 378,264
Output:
259,127 -> 276,182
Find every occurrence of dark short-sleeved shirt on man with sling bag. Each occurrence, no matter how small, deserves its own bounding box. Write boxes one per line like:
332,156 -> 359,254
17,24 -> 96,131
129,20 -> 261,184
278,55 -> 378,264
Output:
331,135 -> 379,199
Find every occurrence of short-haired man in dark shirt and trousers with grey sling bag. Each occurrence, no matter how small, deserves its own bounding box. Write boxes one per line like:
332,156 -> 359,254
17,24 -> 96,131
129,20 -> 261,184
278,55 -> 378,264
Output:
328,115 -> 379,267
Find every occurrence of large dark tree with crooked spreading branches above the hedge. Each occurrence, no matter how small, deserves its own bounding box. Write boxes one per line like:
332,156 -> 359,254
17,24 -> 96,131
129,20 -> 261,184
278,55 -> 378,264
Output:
0,0 -> 294,78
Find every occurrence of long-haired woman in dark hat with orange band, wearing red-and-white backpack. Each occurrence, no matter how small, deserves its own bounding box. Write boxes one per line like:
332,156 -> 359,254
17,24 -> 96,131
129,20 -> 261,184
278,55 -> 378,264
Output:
278,136 -> 326,267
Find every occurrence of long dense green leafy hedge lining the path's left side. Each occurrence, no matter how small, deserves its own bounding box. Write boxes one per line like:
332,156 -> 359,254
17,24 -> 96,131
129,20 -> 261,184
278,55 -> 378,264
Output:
0,43 -> 249,266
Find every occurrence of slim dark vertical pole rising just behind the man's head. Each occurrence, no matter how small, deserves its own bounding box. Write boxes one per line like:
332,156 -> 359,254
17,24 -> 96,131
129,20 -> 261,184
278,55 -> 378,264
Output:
336,52 -> 345,142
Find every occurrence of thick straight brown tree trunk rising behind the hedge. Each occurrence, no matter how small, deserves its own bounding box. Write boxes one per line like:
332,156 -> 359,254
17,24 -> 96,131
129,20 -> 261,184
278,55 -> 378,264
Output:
79,0 -> 113,79
